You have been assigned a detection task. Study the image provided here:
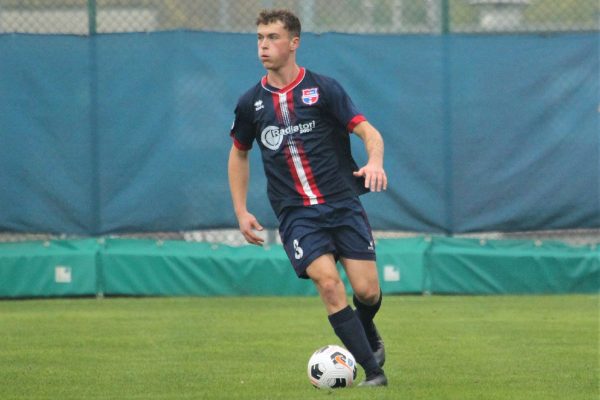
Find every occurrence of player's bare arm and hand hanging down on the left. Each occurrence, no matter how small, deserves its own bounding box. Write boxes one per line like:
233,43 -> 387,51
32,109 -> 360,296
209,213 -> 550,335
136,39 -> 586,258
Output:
227,144 -> 264,246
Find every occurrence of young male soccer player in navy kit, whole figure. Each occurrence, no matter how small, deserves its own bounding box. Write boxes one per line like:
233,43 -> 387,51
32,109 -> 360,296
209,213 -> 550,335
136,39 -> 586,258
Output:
228,10 -> 387,386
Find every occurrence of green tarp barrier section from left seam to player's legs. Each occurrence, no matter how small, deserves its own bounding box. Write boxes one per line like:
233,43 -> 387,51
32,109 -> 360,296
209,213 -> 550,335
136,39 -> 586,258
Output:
101,240 -> 316,296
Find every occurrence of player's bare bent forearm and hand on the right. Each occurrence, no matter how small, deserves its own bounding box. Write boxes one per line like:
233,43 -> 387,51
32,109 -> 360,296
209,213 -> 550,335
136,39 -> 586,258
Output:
353,121 -> 387,192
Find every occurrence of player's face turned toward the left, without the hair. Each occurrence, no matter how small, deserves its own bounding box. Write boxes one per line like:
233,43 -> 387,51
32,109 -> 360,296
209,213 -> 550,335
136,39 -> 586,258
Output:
257,21 -> 300,71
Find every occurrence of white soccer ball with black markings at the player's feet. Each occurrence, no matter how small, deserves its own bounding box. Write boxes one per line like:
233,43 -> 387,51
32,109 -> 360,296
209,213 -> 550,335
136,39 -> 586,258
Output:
308,344 -> 356,389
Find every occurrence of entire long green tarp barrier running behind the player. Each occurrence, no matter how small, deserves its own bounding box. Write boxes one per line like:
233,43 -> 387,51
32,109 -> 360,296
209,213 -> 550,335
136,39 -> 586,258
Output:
0,236 -> 600,298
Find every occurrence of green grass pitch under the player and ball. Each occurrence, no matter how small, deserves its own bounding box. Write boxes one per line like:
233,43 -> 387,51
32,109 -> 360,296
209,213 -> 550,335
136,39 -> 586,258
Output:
0,296 -> 600,400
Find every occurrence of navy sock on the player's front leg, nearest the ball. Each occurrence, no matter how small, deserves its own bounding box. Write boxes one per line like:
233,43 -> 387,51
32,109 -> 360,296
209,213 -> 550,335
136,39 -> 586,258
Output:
329,306 -> 382,379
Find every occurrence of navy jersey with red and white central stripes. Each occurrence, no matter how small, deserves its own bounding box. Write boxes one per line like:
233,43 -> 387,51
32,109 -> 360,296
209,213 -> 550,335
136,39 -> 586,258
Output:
231,68 -> 367,215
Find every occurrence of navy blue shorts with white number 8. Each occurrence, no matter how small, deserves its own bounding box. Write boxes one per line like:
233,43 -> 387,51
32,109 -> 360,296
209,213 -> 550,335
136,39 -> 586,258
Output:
278,197 -> 375,279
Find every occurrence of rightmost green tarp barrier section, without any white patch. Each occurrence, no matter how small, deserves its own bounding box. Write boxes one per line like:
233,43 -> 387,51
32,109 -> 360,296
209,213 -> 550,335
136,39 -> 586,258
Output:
426,238 -> 600,294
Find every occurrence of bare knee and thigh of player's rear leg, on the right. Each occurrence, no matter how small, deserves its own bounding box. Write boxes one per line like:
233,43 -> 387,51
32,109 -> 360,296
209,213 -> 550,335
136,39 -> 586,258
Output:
340,257 -> 380,304
